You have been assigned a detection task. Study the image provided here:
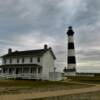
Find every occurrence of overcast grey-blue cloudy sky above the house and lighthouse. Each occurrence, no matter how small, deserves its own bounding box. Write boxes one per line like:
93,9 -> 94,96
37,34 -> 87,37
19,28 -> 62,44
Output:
0,0 -> 100,72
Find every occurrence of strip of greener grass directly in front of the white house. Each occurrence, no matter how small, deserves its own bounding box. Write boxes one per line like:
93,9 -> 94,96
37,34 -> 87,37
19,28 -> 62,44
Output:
0,80 -> 91,88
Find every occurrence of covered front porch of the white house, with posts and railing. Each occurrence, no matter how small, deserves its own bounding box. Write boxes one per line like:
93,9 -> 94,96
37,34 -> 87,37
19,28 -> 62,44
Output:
0,64 -> 42,79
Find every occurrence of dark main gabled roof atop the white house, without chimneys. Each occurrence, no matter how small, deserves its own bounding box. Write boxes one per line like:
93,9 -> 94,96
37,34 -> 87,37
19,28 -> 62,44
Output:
1,48 -> 56,59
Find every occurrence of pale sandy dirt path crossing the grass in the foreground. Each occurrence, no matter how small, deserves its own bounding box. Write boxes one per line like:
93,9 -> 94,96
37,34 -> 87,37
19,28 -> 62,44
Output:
0,86 -> 100,100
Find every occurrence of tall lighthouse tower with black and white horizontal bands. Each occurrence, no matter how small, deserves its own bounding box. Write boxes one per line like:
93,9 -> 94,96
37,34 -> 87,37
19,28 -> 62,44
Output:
66,26 -> 76,75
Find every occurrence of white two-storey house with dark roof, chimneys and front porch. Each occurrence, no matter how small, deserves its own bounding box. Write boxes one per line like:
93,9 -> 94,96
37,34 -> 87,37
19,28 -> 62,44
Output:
0,45 -> 56,80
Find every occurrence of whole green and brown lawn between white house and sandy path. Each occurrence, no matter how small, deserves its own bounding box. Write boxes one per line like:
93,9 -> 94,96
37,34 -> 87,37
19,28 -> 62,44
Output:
0,80 -> 89,94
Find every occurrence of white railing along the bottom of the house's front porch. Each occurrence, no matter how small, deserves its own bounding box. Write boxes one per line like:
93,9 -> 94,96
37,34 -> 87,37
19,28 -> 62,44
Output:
0,73 -> 41,79
